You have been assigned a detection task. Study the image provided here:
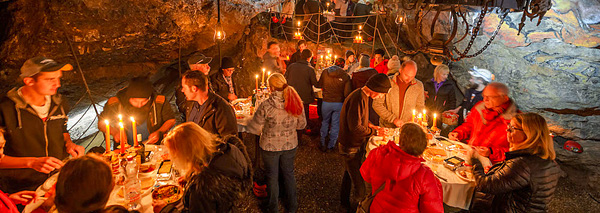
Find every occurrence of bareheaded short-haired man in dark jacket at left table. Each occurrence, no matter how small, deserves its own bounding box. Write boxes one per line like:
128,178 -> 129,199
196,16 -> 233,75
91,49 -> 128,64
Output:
181,71 -> 237,137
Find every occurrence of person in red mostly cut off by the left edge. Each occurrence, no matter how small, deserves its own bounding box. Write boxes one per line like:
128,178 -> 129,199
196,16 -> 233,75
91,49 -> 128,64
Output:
0,128 -> 35,213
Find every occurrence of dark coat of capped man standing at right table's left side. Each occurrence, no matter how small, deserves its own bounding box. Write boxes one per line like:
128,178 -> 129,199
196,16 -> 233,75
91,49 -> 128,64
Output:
337,89 -> 376,154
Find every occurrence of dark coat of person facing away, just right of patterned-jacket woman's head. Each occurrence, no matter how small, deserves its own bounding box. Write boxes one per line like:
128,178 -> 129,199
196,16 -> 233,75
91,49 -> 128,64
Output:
285,61 -> 318,104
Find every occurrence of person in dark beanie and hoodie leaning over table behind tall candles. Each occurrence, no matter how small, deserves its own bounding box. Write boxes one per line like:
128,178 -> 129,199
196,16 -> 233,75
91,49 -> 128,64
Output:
98,77 -> 175,148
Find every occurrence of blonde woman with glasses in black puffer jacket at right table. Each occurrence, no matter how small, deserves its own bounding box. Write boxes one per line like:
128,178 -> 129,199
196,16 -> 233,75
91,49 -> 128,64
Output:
471,113 -> 560,212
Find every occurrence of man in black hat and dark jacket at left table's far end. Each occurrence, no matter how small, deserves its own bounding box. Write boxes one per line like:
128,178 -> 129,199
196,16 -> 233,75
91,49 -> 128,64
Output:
210,57 -> 240,101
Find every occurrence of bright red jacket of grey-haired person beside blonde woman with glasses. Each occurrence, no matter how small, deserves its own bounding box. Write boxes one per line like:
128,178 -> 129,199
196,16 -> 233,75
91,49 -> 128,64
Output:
453,100 -> 519,163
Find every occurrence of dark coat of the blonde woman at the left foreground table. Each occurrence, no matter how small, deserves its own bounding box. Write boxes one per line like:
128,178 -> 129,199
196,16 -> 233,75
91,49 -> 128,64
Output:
182,143 -> 252,212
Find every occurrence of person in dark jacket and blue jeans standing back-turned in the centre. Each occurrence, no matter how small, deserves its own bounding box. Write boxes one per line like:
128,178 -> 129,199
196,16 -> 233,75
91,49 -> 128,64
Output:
319,66 -> 352,151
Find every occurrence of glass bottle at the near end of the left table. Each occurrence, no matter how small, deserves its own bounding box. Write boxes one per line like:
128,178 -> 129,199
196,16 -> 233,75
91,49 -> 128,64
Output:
123,156 -> 142,211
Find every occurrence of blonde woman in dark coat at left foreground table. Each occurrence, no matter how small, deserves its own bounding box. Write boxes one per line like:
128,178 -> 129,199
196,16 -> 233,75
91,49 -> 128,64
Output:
153,122 -> 250,212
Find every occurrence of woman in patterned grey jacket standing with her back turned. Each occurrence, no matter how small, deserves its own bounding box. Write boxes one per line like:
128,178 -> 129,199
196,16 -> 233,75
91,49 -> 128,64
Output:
248,73 -> 306,212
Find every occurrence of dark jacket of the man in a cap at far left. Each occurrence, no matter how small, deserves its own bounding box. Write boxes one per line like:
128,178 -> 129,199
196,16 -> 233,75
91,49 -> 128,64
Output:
0,88 -> 69,194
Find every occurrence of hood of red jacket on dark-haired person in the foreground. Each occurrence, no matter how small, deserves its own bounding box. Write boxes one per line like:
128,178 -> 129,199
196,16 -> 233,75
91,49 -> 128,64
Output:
377,143 -> 425,181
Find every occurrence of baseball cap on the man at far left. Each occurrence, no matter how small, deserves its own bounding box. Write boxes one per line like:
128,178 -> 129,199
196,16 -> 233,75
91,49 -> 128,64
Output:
20,56 -> 73,78
